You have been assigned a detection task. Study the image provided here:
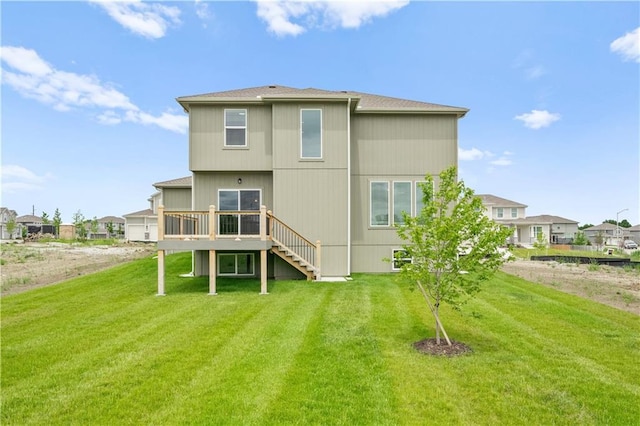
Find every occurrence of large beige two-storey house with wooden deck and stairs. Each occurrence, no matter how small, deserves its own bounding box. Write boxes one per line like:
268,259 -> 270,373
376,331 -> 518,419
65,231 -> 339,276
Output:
158,86 -> 468,294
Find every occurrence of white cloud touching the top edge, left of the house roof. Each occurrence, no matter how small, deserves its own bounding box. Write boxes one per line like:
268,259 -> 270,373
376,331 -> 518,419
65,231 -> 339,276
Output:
90,0 -> 181,38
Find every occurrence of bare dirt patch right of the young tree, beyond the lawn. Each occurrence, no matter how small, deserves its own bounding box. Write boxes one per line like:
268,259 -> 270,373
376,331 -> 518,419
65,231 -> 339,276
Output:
502,260 -> 640,315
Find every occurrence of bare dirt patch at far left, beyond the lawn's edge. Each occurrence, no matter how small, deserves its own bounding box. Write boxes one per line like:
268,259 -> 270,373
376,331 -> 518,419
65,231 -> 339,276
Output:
0,242 -> 156,296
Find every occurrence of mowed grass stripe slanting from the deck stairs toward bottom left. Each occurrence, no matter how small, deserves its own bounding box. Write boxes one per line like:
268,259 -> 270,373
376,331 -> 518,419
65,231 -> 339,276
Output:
150,282 -> 330,424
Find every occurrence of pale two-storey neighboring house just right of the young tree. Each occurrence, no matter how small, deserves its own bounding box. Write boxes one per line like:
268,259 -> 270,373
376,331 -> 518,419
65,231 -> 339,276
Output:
477,194 -> 578,245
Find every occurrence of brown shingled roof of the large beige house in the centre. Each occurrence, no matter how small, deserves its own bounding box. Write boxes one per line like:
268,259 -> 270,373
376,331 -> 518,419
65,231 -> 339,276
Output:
176,85 -> 469,117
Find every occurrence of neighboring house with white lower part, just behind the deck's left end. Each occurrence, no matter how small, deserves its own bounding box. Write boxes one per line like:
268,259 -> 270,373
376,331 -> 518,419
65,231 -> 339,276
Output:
124,176 -> 191,242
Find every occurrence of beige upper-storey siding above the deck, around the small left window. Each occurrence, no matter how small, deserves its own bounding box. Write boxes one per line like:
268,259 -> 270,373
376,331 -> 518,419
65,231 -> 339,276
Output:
189,105 -> 272,171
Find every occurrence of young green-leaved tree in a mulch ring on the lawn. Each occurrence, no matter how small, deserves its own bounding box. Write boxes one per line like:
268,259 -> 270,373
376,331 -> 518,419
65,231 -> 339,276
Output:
395,167 -> 513,345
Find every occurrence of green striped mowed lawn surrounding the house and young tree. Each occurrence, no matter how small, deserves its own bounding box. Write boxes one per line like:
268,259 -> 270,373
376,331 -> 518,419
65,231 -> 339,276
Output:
0,251 -> 640,425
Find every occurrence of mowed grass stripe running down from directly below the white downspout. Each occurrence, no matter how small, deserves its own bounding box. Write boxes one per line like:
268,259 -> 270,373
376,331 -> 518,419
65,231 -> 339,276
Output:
265,282 -> 398,424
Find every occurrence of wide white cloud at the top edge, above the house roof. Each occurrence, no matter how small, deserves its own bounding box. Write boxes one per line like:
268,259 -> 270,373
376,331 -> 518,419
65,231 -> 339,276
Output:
255,0 -> 409,36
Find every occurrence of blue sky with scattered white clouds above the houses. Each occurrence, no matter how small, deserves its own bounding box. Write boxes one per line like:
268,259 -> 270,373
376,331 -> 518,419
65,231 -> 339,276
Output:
0,1 -> 640,225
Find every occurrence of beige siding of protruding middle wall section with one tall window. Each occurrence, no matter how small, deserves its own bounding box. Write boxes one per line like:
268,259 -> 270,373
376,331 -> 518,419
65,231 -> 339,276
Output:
273,103 -> 348,276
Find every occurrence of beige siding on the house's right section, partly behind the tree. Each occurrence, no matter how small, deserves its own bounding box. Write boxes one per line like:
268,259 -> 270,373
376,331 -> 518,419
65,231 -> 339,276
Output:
351,114 -> 458,272
